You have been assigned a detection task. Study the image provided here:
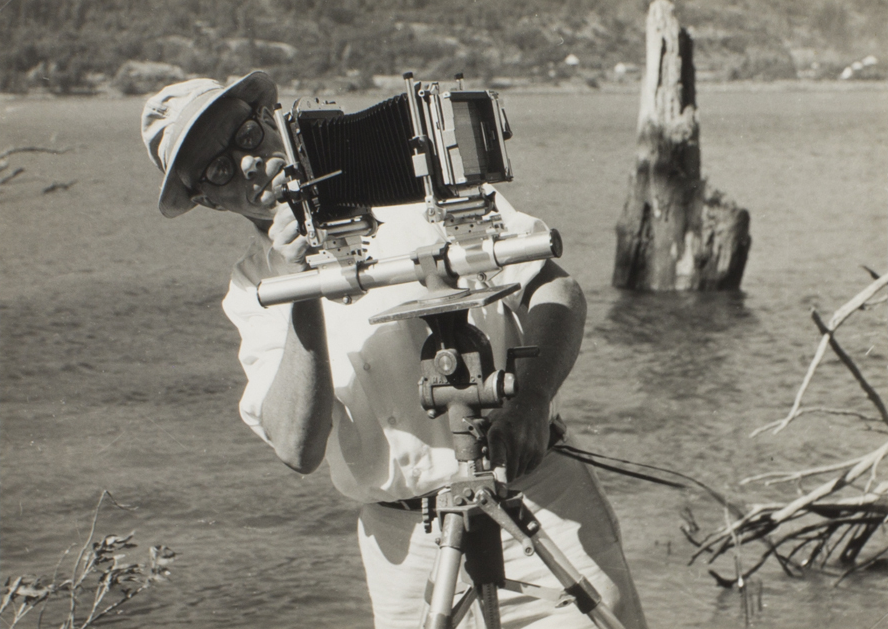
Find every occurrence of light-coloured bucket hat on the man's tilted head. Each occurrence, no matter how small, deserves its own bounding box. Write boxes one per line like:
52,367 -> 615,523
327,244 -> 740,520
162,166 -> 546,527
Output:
142,72 -> 277,218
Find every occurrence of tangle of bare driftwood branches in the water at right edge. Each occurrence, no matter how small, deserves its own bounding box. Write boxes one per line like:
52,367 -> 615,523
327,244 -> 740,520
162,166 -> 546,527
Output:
685,269 -> 888,587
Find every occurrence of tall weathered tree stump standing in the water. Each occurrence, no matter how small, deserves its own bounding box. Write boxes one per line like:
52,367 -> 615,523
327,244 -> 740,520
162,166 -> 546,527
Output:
613,0 -> 751,290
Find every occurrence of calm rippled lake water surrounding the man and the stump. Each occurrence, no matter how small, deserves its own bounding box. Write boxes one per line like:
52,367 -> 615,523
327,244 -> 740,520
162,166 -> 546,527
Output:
0,86 -> 888,629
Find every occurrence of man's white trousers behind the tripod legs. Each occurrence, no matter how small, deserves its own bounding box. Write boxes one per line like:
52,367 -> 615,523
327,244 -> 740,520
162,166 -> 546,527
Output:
358,453 -> 647,629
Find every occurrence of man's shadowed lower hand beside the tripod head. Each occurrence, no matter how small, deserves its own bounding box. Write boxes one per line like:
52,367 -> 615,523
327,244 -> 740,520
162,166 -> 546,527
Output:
487,395 -> 549,481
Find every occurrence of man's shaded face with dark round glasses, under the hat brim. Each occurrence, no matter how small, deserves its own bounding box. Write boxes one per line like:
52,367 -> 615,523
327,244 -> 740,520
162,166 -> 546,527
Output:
176,98 -> 286,220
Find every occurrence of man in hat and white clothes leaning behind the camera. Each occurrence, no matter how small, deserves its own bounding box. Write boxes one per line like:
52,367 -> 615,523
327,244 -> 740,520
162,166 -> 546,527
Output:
142,72 -> 645,629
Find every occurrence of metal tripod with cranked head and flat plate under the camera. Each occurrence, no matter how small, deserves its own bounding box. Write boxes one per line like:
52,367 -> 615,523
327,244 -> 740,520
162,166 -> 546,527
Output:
370,284 -> 623,629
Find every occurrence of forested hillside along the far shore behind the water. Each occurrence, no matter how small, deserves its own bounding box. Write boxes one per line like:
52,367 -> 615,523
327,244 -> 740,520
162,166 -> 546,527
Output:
0,0 -> 888,93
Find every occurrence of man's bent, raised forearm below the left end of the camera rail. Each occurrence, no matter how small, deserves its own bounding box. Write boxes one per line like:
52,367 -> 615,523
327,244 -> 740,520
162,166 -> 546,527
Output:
262,300 -> 333,474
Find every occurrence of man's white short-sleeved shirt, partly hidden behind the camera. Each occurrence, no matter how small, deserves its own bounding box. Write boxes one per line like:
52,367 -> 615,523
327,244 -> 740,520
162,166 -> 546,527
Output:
222,195 -> 554,502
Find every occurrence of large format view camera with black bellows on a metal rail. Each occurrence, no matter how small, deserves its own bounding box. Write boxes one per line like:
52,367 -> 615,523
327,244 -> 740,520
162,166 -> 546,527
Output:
258,73 -> 561,306
